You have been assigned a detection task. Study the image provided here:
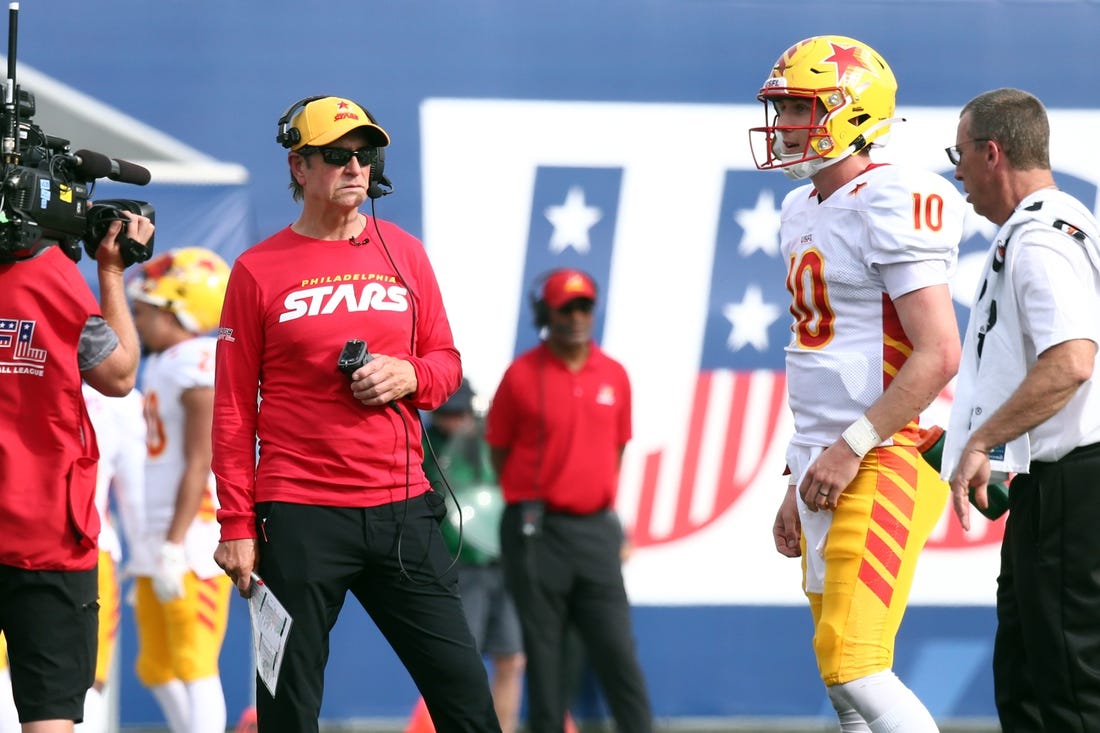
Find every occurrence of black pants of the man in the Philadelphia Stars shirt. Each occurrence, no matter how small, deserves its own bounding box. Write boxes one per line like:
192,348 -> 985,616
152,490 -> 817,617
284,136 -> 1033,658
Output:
256,493 -> 501,733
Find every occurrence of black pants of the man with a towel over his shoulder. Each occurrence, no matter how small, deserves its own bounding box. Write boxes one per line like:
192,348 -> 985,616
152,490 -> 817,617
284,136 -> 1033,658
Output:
993,445 -> 1100,733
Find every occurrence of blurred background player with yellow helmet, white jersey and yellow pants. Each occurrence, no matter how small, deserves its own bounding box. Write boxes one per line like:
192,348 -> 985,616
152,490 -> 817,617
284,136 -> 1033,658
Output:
128,247 -> 232,733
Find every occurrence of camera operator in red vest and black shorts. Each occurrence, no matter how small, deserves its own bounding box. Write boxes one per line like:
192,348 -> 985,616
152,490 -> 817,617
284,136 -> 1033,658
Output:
0,215 -> 153,733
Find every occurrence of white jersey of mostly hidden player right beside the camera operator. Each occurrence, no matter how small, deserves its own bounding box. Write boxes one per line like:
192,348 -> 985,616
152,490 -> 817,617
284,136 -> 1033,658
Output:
83,383 -> 145,562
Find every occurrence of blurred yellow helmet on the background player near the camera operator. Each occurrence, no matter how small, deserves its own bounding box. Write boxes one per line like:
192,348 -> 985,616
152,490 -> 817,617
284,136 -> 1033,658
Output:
127,247 -> 229,333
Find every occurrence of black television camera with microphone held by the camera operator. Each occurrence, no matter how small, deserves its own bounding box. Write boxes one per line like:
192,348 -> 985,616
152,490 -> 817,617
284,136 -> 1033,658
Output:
0,2 -> 154,266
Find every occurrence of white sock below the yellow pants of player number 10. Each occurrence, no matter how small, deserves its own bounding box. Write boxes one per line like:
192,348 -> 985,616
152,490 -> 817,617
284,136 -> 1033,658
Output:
829,669 -> 939,733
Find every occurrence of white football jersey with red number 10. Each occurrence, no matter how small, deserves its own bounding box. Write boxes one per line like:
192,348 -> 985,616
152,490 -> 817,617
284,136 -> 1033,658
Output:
780,165 -> 966,446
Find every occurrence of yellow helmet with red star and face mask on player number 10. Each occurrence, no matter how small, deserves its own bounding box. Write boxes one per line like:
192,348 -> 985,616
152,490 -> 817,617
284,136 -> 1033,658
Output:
749,35 -> 899,178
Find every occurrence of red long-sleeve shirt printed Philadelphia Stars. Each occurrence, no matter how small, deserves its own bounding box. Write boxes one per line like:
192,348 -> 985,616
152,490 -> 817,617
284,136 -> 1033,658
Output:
213,219 -> 462,540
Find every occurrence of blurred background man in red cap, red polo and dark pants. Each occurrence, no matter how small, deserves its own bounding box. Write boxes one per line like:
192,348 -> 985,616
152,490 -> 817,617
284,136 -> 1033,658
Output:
485,270 -> 653,733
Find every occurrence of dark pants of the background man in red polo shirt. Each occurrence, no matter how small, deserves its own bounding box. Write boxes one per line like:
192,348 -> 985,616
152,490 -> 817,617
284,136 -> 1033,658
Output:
501,505 -> 653,733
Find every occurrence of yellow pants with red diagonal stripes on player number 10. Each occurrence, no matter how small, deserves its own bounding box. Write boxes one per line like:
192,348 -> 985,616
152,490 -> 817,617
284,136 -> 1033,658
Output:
803,446 -> 948,685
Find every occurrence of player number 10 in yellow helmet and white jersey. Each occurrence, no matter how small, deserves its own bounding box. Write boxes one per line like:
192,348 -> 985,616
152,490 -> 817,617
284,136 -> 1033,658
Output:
750,36 -> 964,733
